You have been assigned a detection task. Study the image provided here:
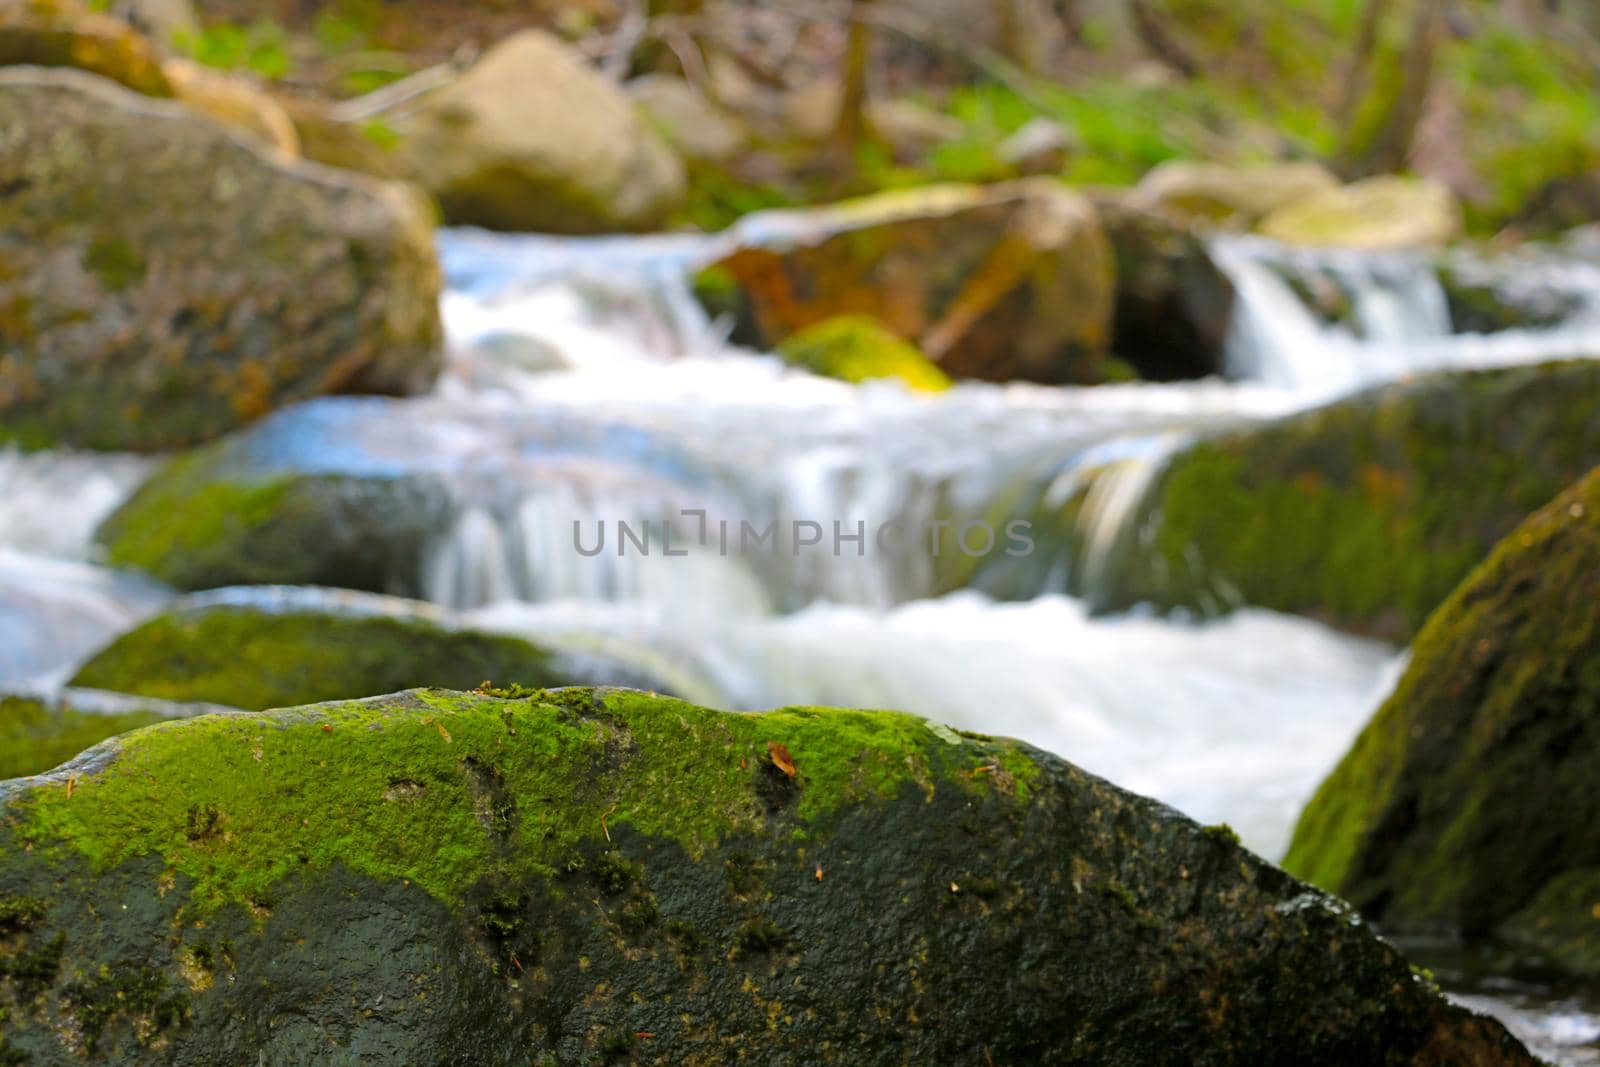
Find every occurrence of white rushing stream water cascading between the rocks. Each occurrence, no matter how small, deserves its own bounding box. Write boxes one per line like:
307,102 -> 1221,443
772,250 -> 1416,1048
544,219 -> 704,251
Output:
0,225 -> 1600,1064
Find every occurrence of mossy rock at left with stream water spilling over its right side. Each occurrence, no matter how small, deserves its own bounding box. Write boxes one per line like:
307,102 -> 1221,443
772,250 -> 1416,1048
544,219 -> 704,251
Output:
96,397 -> 733,606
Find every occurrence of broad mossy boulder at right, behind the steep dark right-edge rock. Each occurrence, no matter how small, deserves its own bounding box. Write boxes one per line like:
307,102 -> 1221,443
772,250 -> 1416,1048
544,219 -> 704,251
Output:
1101,360 -> 1600,641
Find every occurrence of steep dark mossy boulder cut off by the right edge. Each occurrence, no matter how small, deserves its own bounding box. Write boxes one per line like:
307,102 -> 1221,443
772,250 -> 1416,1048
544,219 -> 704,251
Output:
1285,472 -> 1600,976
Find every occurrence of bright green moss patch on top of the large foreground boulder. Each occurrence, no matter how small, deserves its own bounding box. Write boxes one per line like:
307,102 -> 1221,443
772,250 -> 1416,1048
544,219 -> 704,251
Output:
13,689 -> 1027,923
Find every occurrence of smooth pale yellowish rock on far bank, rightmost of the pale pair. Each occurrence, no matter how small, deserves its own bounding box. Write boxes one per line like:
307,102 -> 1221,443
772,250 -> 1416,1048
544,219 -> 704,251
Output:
1256,176 -> 1462,250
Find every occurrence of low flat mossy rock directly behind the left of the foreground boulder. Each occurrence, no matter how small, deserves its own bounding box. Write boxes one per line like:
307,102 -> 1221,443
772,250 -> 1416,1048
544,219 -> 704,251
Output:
72,587 -> 667,710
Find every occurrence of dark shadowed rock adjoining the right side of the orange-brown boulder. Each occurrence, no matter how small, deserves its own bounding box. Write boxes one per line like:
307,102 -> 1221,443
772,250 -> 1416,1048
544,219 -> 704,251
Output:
1096,195 -> 1234,381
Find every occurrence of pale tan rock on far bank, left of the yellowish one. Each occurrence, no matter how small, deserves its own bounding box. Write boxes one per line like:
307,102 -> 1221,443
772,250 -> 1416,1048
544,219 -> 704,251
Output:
1136,162 -> 1339,230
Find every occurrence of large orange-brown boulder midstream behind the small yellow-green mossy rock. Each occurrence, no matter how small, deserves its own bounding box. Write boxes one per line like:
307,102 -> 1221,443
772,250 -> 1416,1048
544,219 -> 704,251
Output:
717,179 -> 1115,382
